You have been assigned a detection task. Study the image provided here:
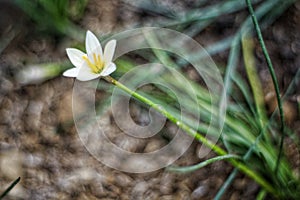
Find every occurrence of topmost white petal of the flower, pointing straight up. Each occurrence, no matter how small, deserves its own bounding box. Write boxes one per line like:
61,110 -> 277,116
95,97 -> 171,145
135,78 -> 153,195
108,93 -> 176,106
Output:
85,31 -> 103,57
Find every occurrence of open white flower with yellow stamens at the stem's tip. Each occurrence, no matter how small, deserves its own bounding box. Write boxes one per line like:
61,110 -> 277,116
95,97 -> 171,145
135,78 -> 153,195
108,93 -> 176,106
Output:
63,31 -> 116,81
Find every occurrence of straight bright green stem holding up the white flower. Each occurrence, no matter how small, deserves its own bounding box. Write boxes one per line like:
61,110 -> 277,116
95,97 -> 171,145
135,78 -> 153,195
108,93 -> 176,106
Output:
104,76 -> 278,196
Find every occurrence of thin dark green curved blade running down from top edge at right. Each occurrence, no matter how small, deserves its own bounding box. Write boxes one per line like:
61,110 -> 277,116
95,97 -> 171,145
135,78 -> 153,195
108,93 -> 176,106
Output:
246,0 -> 285,174
